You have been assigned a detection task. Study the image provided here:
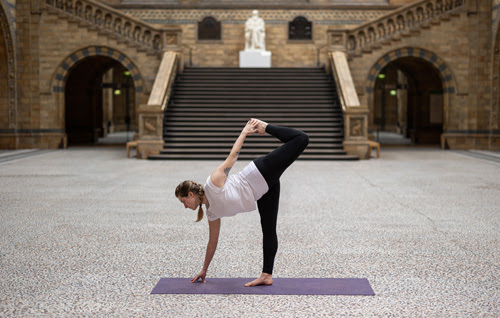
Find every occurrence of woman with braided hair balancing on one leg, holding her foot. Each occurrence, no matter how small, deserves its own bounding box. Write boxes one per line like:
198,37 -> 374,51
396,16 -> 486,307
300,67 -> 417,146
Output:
175,118 -> 309,287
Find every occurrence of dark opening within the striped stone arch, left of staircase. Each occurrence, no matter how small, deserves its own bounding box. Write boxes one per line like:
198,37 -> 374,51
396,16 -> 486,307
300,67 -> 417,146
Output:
64,56 -> 136,146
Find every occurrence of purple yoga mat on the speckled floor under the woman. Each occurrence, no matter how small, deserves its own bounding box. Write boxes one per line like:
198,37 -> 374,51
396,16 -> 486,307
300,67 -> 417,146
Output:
151,278 -> 375,296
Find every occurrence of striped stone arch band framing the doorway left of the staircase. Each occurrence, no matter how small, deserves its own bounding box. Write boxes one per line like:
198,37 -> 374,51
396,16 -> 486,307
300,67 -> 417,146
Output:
51,46 -> 144,139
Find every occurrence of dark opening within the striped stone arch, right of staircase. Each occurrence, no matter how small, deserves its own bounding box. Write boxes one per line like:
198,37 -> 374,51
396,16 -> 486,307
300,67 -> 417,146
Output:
370,57 -> 444,144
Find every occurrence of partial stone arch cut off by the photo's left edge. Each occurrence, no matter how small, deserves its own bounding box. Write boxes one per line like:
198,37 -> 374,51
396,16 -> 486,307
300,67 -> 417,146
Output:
0,1 -> 17,129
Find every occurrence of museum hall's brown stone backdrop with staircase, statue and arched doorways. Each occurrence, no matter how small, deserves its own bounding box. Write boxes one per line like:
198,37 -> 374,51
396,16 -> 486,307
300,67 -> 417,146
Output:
0,0 -> 500,160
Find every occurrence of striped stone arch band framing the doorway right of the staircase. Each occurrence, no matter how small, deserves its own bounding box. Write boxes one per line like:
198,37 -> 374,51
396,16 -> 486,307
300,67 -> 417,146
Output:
365,47 -> 457,144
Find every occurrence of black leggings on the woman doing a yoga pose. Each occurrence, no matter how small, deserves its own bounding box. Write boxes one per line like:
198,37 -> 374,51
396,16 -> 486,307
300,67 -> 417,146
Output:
254,125 -> 309,274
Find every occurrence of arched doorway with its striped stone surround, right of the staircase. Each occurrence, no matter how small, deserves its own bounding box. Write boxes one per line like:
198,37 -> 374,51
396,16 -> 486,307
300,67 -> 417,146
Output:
365,47 -> 458,147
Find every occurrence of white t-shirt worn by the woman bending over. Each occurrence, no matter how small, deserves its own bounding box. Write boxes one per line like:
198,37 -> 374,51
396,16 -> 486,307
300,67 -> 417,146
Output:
203,161 -> 269,221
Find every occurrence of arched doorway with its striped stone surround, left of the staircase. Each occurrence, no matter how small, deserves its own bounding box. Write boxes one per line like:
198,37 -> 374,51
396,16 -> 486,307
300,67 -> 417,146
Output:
51,46 -> 146,145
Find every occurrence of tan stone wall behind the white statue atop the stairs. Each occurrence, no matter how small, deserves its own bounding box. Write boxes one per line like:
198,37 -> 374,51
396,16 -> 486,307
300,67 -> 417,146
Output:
123,8 -> 387,67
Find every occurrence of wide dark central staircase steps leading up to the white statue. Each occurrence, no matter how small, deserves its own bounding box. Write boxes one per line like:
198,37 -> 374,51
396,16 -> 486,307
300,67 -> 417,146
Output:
149,68 -> 358,160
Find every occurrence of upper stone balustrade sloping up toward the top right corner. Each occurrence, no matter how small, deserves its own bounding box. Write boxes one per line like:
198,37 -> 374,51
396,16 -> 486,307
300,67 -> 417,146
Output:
328,0 -> 466,53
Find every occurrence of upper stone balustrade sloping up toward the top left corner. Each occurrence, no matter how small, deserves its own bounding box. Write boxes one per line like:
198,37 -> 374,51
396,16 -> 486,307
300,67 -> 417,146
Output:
45,0 -> 181,53
